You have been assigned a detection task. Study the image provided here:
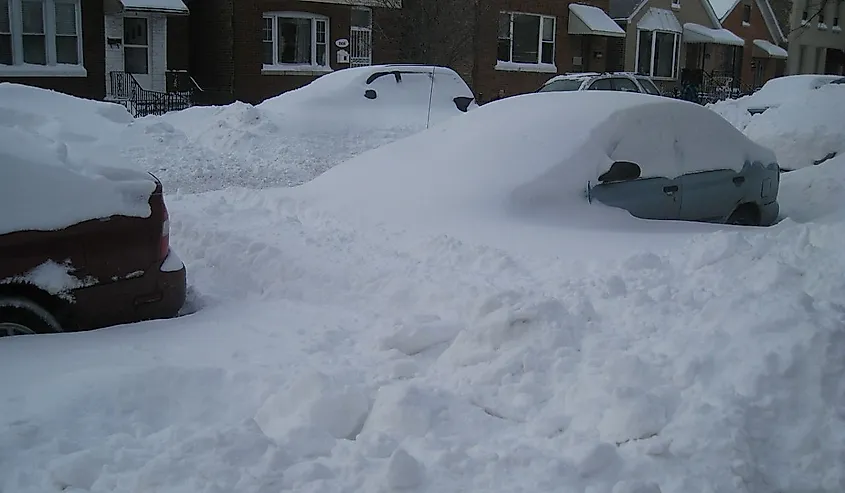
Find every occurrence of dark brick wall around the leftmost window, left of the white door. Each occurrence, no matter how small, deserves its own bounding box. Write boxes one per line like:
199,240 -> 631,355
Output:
0,0 -> 106,99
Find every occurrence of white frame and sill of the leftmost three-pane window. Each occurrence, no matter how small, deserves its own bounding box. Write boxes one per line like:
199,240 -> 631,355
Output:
0,0 -> 88,77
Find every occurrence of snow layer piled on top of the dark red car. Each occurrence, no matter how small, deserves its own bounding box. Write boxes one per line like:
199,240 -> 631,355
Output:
0,104 -> 156,234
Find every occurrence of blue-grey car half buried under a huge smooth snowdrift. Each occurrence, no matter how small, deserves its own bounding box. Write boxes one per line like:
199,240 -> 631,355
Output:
298,91 -> 780,244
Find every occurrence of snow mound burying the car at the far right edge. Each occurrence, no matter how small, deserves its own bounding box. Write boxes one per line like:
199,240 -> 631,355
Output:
708,79 -> 845,170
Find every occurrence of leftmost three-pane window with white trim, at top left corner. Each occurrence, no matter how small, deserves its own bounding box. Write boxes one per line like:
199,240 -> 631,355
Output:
0,0 -> 82,71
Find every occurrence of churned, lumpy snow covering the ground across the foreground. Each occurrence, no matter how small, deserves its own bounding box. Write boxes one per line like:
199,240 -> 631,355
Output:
0,84 -> 845,493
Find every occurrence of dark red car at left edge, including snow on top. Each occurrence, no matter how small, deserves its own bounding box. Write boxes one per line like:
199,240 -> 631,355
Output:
0,128 -> 186,336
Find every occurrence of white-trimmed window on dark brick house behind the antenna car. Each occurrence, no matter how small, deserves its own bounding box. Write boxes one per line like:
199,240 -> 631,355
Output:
262,12 -> 329,70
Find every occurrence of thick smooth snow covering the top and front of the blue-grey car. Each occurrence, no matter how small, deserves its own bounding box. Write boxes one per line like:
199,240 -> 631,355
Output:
298,91 -> 774,242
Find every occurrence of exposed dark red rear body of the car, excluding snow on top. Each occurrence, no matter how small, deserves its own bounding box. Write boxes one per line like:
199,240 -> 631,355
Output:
0,171 -> 186,336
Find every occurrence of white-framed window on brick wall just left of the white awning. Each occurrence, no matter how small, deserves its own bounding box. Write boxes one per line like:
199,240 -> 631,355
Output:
497,12 -> 555,65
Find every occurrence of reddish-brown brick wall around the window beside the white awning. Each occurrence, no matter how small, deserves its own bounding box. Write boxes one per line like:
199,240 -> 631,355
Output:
473,0 -> 608,103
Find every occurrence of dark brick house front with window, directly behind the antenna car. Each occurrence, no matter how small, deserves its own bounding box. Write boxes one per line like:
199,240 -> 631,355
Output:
188,0 -> 393,103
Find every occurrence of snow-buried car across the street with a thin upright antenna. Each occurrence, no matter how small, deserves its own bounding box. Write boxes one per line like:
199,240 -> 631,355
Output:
258,64 -> 478,124
